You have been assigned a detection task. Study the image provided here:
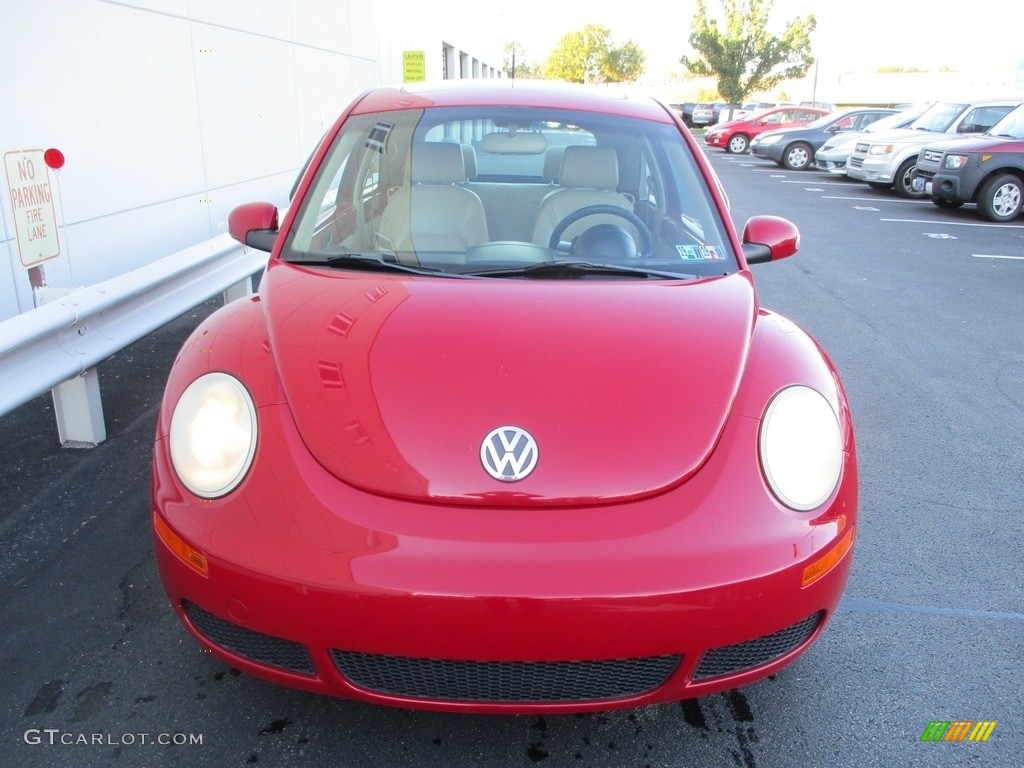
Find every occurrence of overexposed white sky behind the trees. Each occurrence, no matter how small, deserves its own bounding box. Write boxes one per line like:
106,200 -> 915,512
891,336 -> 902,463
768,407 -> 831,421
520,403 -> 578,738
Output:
387,0 -> 1024,82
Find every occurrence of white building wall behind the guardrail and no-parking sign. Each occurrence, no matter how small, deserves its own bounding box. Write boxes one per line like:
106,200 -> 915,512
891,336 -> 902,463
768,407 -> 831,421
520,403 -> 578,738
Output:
0,0 -> 497,321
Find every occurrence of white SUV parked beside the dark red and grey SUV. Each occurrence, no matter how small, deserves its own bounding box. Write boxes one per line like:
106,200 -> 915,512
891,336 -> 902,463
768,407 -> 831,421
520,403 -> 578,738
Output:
846,97 -> 1024,198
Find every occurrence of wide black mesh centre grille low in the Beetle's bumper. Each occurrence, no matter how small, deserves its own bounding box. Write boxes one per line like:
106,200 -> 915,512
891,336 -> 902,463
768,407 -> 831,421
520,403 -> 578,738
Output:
331,650 -> 680,703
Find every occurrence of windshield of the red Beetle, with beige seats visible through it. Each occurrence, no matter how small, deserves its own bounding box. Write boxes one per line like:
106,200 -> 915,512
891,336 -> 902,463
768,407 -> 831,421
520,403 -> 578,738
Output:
282,105 -> 738,279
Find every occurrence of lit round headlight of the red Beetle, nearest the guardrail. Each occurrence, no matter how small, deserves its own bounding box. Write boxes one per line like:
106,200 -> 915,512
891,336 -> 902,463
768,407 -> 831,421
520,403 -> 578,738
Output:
170,373 -> 256,499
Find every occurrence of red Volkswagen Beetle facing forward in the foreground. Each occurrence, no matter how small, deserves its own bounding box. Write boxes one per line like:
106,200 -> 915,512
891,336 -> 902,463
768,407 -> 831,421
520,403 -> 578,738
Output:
153,81 -> 857,713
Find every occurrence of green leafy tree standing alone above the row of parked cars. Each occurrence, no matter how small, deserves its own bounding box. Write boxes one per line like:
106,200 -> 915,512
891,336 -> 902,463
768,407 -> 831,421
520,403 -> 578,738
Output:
679,0 -> 816,109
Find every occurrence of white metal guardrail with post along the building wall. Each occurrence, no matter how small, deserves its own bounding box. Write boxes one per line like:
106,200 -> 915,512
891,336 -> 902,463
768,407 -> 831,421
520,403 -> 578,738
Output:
0,234 -> 267,447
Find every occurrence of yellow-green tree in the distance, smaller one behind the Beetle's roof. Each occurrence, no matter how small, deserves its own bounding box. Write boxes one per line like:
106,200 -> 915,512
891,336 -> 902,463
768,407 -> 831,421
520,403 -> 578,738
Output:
544,24 -> 646,83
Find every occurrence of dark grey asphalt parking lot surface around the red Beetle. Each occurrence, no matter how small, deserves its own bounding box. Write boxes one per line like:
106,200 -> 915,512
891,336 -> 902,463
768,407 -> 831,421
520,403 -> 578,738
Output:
0,151 -> 1024,768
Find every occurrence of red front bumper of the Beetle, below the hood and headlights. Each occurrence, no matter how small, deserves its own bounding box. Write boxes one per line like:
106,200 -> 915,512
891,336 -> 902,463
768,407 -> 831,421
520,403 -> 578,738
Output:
153,406 -> 857,712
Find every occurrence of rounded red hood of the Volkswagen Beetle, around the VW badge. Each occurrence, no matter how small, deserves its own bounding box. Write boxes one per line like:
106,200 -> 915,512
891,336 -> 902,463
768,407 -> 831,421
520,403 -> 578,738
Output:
261,262 -> 756,506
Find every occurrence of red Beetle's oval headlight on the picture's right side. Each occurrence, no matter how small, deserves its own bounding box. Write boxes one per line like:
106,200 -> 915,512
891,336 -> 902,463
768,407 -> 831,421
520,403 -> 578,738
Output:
760,386 -> 843,511
